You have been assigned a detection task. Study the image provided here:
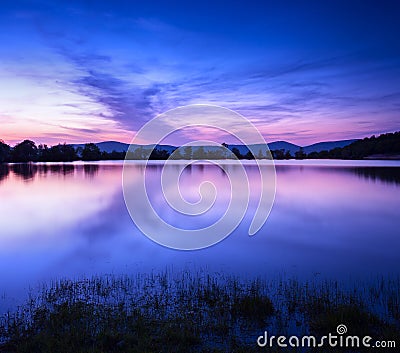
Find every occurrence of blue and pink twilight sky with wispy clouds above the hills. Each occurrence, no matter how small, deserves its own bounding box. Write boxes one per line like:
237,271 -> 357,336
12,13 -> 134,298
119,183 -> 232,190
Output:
0,0 -> 400,145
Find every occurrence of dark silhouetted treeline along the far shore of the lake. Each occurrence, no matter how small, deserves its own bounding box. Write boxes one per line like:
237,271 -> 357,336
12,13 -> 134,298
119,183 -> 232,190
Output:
0,132 -> 400,163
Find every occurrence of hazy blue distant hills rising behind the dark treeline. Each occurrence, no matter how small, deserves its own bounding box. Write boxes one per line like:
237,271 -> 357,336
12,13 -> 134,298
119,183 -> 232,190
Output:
72,140 -> 357,155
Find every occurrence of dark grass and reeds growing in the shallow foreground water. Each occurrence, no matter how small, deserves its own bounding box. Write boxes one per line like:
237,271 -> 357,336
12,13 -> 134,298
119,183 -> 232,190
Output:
0,271 -> 400,353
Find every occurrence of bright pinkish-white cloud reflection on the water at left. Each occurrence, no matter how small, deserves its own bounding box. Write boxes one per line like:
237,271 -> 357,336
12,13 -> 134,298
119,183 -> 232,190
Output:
0,163 -> 121,242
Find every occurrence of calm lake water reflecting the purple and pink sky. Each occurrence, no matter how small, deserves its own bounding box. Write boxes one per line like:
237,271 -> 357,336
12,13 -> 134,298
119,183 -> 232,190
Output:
0,161 -> 400,311
